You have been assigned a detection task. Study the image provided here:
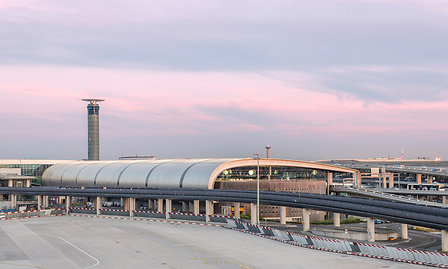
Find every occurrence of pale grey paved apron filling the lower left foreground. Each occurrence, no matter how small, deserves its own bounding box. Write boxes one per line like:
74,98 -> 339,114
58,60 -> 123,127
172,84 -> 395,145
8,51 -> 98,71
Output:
0,216 -> 427,269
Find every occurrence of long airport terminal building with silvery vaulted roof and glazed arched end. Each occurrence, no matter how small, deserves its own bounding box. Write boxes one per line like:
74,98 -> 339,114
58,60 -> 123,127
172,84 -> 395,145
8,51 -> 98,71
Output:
0,158 -> 359,219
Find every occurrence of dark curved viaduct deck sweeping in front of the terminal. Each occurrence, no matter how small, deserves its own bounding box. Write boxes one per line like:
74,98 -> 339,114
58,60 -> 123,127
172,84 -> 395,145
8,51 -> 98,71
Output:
0,187 -> 448,230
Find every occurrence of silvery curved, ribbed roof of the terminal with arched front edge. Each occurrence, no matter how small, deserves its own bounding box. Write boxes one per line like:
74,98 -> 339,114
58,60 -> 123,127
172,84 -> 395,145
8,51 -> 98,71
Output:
42,159 -> 359,189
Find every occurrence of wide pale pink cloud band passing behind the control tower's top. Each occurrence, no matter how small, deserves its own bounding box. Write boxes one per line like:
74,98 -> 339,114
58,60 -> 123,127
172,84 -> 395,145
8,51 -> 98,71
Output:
0,66 -> 448,138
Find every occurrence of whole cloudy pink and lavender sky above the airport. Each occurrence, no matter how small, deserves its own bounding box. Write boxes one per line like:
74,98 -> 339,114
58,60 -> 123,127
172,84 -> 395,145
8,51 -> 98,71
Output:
0,0 -> 448,160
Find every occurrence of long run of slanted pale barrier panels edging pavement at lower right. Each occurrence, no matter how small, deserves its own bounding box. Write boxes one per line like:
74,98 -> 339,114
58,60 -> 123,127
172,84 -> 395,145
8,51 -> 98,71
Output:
226,219 -> 448,268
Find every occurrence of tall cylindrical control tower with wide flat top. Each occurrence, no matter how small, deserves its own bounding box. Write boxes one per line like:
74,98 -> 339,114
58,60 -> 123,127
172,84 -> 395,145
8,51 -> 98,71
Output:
82,99 -> 104,161
